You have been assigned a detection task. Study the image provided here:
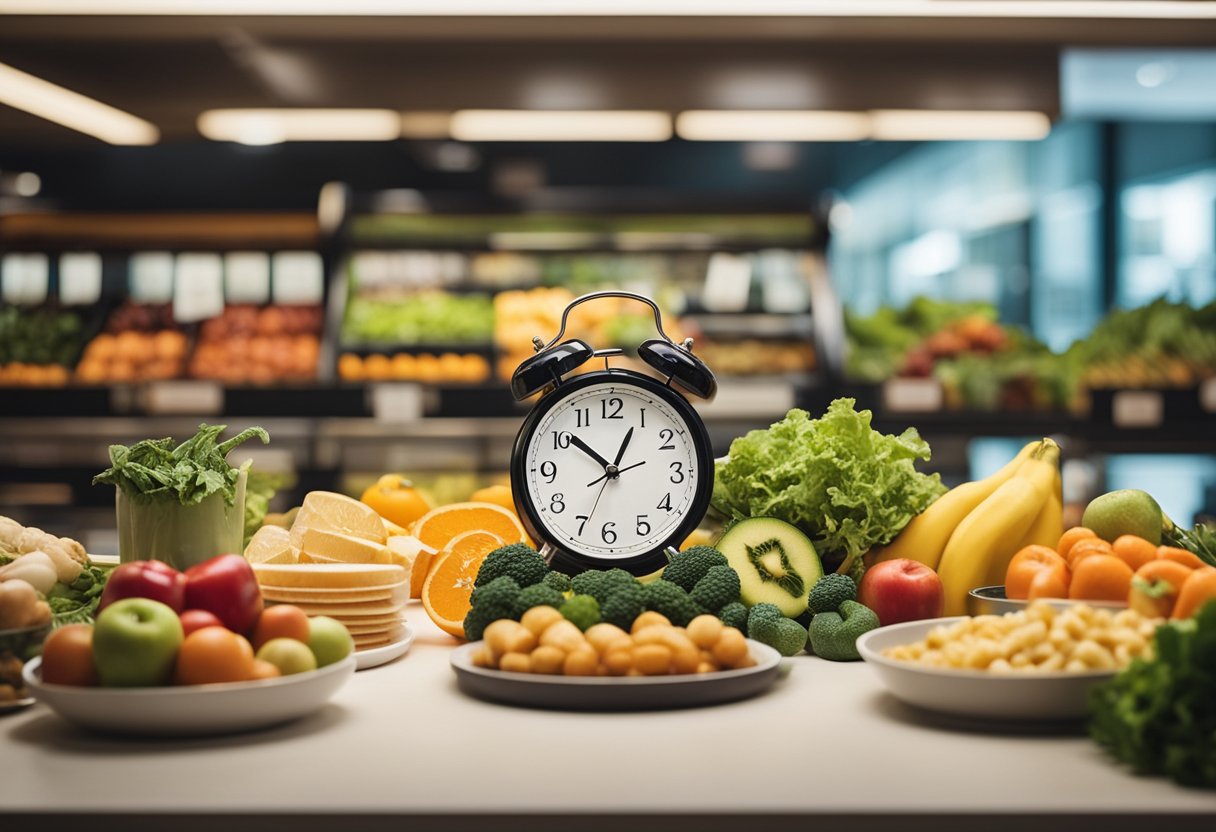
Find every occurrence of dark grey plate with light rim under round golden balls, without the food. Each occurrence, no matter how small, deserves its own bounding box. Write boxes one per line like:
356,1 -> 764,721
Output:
451,639 -> 781,710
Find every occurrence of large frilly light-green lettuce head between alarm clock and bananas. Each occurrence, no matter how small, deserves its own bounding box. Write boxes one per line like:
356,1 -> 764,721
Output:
714,399 -> 946,569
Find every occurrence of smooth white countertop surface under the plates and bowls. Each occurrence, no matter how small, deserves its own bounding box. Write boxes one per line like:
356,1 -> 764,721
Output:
0,603 -> 1216,832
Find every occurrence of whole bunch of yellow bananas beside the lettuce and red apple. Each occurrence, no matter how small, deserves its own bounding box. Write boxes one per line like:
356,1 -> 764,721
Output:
872,439 -> 1064,615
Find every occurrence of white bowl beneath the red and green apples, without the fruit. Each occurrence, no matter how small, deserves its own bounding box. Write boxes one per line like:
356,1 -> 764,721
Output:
23,656 -> 355,736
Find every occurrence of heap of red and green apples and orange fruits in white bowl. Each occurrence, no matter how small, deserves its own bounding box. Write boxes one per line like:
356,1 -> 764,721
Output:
41,555 -> 354,687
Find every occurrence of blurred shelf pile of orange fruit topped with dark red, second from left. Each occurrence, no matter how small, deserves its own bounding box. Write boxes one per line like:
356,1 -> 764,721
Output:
75,302 -> 188,384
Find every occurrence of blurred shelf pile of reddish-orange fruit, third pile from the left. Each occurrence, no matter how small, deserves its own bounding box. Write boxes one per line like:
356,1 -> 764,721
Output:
187,305 -> 325,384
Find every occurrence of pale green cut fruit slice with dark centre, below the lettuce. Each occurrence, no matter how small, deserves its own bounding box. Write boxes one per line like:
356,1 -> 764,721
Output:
717,517 -> 823,618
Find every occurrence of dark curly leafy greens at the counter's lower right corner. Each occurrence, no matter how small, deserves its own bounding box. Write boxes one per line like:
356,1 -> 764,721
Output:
1090,602 -> 1216,788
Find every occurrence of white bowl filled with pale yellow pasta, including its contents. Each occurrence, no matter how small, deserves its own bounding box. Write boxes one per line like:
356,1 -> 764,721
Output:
857,602 -> 1158,720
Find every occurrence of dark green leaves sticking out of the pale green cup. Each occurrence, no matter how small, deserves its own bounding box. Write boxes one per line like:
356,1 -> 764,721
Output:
92,423 -> 270,506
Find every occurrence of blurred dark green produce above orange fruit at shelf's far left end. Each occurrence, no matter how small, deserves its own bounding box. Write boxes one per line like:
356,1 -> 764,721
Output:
0,304 -> 88,387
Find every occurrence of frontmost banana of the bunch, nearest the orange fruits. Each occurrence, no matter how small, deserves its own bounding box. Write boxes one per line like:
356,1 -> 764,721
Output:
938,439 -> 1060,615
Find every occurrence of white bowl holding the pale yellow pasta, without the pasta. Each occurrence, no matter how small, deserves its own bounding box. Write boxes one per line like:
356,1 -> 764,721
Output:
857,615 -> 1115,720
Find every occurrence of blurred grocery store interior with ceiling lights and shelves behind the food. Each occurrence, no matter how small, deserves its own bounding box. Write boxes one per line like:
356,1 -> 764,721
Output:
0,0 -> 1216,551
